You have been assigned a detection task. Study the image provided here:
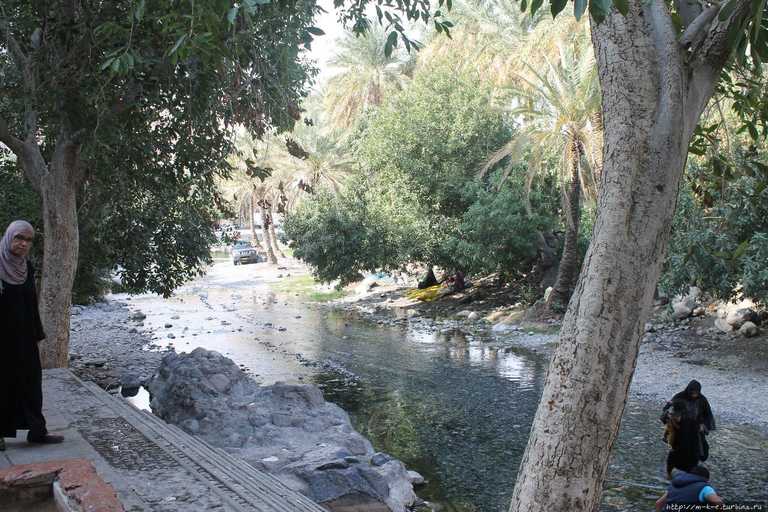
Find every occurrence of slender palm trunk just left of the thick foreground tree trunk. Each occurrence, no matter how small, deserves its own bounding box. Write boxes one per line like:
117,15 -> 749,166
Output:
550,141 -> 581,304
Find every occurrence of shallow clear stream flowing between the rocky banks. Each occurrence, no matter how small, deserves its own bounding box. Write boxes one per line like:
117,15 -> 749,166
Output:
126,266 -> 768,512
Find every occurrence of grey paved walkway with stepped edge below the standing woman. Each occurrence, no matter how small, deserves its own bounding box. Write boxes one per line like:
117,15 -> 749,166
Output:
0,368 -> 325,512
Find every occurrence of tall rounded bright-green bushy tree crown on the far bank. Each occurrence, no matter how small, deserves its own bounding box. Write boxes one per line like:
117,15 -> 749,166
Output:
359,61 -> 509,264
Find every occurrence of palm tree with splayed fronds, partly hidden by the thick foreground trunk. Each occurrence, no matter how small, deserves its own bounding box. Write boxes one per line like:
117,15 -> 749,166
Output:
481,45 -> 602,304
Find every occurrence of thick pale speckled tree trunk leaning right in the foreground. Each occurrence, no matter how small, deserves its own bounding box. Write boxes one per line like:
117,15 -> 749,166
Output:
510,0 -> 728,512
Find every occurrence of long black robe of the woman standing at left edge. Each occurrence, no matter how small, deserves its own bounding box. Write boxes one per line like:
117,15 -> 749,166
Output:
0,261 -> 47,437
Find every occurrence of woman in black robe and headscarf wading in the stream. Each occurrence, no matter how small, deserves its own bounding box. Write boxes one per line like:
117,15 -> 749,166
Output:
661,380 -> 715,479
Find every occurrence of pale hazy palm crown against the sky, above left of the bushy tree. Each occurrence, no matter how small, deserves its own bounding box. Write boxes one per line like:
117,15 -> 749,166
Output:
325,24 -> 413,128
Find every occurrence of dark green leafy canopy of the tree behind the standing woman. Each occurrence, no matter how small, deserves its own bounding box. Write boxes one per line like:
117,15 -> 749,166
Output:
0,0 -> 320,301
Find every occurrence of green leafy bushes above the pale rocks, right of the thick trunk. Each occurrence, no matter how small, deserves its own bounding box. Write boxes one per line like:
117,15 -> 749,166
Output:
659,170 -> 768,302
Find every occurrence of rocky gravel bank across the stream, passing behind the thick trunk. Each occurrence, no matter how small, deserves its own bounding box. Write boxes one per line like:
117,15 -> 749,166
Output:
326,278 -> 768,431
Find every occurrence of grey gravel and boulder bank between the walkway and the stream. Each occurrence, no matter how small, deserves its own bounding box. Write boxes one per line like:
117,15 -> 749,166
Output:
70,266 -> 423,512
